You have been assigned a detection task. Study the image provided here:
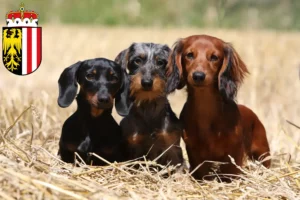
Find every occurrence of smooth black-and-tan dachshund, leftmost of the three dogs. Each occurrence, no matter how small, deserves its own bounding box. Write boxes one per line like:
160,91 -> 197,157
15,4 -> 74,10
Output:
58,58 -> 126,165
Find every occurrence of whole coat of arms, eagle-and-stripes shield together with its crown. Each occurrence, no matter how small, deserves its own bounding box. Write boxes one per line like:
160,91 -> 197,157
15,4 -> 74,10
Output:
2,3 -> 42,75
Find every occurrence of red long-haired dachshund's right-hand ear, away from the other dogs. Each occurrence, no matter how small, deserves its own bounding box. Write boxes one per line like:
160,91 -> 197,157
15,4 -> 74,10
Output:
218,43 -> 249,100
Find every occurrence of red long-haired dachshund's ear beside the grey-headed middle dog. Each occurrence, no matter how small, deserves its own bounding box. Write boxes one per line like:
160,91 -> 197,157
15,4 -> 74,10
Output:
167,39 -> 185,93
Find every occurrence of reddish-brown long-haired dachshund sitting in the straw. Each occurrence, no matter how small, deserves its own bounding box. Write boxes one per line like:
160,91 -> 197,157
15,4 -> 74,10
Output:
168,35 -> 271,181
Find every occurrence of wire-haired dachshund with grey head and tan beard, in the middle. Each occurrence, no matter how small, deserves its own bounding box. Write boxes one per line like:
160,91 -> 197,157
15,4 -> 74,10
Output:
115,43 -> 183,165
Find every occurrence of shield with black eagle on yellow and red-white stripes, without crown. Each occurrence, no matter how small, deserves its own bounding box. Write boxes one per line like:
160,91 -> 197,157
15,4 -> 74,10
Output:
2,27 -> 42,75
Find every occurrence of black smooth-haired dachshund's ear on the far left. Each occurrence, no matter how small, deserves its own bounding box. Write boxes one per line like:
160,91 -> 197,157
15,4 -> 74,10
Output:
57,61 -> 82,108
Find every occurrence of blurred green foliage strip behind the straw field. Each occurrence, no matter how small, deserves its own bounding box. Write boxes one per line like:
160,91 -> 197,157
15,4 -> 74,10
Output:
0,0 -> 300,30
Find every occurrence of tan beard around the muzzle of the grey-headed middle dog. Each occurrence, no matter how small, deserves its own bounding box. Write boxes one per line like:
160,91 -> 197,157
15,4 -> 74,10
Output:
130,73 -> 166,102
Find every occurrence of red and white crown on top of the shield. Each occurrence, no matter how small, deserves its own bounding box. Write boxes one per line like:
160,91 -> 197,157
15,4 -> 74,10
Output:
6,3 -> 38,27
